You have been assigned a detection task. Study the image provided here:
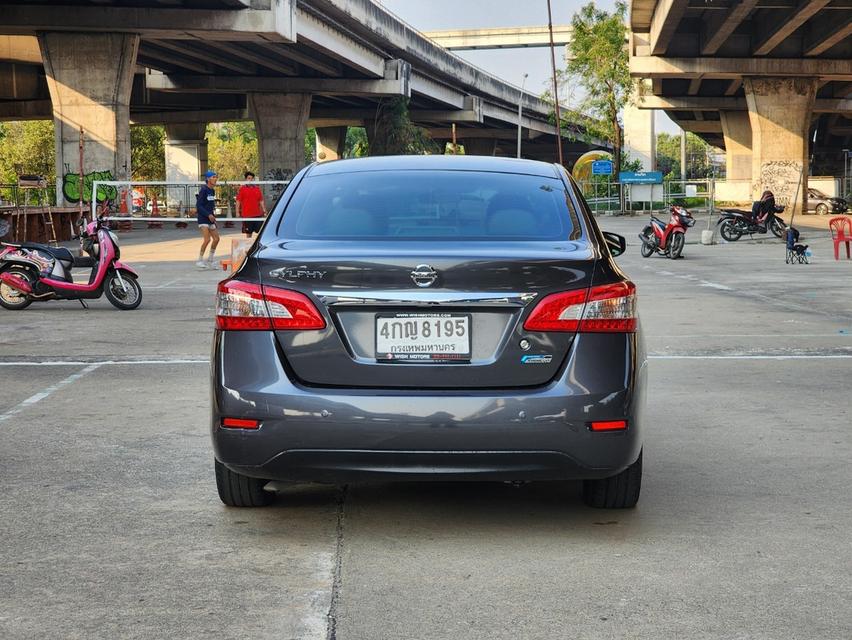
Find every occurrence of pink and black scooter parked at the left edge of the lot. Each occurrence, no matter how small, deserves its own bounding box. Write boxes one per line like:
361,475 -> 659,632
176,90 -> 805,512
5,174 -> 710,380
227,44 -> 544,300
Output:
0,217 -> 142,310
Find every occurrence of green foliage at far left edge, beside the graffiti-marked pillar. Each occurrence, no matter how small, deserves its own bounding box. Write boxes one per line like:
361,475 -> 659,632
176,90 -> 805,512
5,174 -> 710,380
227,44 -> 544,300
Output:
0,120 -> 56,184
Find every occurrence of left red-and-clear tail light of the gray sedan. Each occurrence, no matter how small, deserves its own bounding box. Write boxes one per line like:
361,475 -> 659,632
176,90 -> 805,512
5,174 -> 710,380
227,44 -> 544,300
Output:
216,280 -> 325,331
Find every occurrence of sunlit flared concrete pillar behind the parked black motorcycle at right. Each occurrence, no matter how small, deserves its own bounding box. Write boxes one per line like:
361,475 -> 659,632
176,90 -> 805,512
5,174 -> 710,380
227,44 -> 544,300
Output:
743,78 -> 818,220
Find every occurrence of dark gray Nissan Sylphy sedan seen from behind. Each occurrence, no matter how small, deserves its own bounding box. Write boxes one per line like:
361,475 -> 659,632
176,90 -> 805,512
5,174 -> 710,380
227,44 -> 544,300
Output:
211,156 -> 646,508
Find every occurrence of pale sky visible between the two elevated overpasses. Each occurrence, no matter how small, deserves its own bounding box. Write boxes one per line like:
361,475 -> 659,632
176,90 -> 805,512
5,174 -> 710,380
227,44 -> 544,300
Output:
373,0 -> 680,133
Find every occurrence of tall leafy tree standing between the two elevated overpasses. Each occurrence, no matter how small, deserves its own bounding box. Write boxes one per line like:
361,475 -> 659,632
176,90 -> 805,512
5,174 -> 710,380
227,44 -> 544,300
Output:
559,2 -> 633,175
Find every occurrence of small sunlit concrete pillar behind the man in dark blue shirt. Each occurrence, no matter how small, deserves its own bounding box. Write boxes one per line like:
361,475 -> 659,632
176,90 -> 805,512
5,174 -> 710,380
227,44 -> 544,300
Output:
165,122 -> 208,211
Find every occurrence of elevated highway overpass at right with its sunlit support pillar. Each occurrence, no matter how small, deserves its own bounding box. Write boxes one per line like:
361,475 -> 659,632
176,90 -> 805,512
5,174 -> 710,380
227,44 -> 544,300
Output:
630,0 -> 852,210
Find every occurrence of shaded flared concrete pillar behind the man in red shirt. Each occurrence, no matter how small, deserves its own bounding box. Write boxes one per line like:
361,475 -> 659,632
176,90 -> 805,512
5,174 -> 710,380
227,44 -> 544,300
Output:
248,93 -> 311,180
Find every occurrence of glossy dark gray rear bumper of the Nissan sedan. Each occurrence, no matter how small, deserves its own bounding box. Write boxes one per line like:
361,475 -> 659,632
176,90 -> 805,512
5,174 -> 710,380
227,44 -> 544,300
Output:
211,332 -> 646,483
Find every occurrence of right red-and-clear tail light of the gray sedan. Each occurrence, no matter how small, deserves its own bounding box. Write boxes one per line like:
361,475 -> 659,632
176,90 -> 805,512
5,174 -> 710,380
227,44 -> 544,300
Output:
524,282 -> 636,333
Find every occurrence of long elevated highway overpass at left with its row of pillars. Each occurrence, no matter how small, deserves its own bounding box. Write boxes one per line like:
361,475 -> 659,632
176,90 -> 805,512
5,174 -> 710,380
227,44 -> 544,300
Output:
0,0 -> 603,204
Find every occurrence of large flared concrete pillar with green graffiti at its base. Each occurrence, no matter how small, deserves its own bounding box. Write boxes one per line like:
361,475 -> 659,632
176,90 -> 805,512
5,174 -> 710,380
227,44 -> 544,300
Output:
39,32 -> 139,202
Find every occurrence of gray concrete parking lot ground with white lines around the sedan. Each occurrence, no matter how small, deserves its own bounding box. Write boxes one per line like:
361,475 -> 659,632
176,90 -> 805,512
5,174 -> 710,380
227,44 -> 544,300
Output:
0,216 -> 852,640
